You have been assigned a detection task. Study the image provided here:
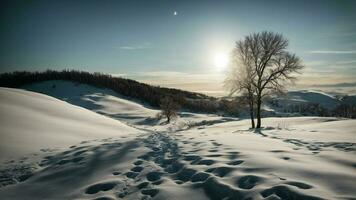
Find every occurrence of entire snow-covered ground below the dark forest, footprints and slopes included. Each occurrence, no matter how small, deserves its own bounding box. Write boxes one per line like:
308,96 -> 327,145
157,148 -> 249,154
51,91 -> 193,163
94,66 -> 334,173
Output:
0,81 -> 356,200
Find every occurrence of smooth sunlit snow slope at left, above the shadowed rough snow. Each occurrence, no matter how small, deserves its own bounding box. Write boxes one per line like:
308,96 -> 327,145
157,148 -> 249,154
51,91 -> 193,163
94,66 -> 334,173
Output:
0,88 -> 139,161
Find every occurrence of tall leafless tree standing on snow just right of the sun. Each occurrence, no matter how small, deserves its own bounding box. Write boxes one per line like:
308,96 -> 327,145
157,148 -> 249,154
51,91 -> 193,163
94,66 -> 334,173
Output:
225,31 -> 304,128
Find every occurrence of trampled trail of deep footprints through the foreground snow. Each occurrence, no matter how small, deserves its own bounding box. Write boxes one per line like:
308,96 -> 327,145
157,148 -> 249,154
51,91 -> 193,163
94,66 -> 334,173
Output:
85,133 -> 319,200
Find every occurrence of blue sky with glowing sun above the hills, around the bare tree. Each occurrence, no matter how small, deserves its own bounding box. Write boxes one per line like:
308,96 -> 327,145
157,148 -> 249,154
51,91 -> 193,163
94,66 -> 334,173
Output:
0,0 -> 356,93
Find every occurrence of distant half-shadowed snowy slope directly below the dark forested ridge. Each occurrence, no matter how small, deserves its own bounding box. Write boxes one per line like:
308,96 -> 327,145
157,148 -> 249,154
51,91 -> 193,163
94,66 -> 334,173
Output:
24,81 -> 158,123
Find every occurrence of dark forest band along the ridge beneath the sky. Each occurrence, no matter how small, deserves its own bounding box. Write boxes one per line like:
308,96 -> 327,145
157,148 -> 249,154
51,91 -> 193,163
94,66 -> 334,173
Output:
0,70 -> 238,114
